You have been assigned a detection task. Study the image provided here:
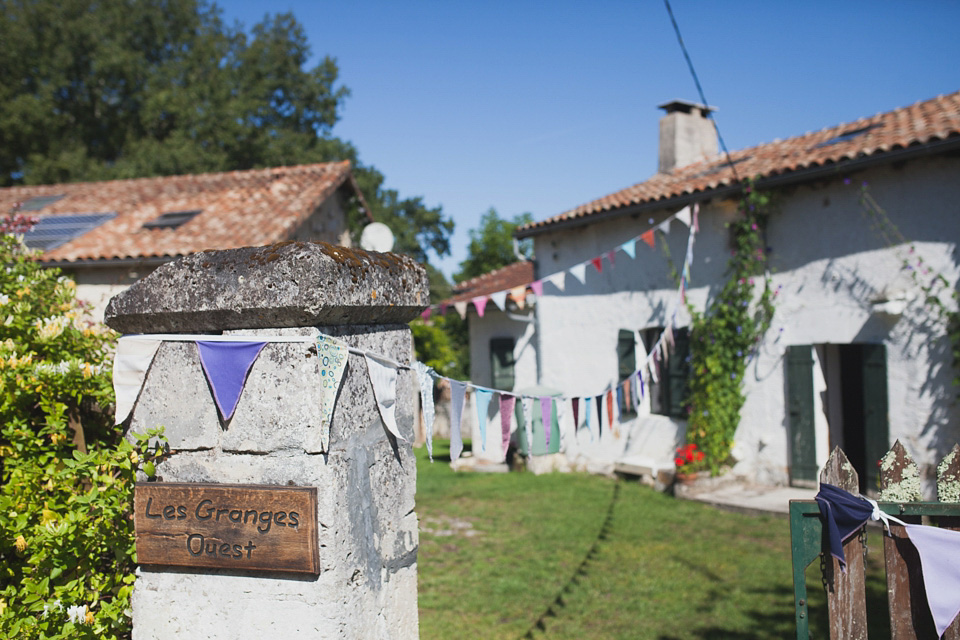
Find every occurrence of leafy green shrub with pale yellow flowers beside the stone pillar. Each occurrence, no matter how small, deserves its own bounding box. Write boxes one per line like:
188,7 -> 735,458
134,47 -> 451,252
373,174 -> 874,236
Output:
0,228 -> 161,638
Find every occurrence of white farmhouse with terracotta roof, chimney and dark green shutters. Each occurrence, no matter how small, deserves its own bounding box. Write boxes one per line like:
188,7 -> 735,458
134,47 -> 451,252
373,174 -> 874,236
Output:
462,92 -> 960,490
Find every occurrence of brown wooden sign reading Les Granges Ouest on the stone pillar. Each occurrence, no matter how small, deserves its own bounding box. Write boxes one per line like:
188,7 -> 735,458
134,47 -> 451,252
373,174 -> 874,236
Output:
133,482 -> 320,575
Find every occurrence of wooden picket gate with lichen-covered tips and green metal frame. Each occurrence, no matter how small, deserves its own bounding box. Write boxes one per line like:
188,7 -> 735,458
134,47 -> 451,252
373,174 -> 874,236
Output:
790,441 -> 960,640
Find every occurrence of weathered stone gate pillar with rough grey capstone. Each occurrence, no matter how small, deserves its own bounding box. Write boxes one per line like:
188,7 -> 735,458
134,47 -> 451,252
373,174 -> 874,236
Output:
106,242 -> 428,640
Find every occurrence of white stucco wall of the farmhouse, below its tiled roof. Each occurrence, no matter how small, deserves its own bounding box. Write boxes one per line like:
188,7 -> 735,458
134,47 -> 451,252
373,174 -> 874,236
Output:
488,158 -> 960,483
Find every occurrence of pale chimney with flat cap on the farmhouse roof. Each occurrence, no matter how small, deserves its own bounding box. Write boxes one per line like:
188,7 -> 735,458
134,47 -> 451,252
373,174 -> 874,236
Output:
657,100 -> 719,173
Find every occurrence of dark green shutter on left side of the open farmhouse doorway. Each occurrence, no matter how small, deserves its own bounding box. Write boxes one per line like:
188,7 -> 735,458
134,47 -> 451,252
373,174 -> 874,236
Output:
787,344 -> 818,484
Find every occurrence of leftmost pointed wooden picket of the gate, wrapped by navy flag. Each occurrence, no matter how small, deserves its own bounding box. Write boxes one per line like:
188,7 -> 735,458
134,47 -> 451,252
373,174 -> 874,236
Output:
820,447 -> 867,640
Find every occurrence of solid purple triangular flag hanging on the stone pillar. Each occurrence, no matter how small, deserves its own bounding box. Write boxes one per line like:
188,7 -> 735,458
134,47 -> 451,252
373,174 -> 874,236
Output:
196,340 -> 267,422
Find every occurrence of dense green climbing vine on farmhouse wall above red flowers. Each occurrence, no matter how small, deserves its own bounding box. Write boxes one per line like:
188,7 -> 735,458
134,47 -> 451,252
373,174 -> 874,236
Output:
687,182 -> 776,473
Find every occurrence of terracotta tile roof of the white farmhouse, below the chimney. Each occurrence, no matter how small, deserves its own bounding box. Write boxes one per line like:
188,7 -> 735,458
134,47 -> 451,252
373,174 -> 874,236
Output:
517,91 -> 960,237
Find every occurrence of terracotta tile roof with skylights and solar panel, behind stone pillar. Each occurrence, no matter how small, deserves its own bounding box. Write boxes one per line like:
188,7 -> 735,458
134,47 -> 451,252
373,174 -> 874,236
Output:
0,161 -> 366,262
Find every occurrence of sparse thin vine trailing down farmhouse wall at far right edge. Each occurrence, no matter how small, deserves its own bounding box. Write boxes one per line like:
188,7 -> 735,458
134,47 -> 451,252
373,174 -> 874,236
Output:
846,179 -> 960,386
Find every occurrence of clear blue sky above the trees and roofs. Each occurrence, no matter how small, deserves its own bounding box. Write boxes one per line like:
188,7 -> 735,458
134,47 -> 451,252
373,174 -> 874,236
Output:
223,0 -> 960,275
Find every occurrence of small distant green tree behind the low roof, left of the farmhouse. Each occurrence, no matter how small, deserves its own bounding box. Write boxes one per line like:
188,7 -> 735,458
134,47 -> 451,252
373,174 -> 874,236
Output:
453,207 -> 533,282
